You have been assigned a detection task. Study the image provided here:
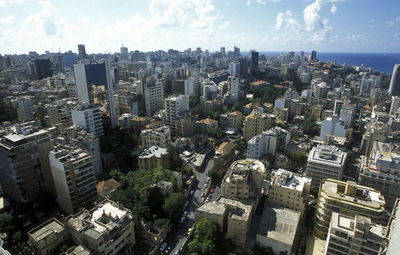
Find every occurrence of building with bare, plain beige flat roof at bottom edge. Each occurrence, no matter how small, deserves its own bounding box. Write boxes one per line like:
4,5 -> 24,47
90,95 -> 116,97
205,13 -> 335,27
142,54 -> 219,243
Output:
256,207 -> 301,255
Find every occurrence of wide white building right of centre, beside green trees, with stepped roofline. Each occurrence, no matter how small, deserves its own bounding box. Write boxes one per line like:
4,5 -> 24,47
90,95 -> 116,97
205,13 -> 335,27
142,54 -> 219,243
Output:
246,127 -> 290,159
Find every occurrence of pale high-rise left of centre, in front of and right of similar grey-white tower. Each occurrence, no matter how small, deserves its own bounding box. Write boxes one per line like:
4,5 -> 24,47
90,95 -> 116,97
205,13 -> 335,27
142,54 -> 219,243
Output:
164,95 -> 193,137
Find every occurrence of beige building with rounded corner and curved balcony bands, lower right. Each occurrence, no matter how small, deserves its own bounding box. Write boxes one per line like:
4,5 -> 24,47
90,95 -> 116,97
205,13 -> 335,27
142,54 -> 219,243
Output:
313,179 -> 387,238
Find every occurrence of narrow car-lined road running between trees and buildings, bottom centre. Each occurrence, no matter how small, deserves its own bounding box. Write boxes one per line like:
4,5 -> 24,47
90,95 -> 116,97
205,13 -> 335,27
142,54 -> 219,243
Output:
158,157 -> 214,254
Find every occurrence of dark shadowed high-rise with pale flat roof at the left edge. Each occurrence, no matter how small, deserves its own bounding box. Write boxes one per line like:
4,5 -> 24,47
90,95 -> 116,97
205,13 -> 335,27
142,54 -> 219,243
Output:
0,121 -> 54,203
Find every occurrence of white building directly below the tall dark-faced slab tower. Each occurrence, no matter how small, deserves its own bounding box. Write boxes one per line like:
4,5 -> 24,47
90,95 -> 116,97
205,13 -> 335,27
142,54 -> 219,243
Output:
71,104 -> 104,137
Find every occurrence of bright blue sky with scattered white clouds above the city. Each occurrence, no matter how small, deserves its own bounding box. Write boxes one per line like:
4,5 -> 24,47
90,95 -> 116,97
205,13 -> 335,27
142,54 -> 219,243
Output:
0,0 -> 400,54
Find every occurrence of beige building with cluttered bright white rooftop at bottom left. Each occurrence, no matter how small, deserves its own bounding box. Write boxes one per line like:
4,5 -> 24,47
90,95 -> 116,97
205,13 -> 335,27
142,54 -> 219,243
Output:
66,200 -> 136,255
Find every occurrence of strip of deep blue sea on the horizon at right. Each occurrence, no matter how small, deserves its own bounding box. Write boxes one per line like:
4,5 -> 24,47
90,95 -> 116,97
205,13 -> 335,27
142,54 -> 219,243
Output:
248,51 -> 400,74
